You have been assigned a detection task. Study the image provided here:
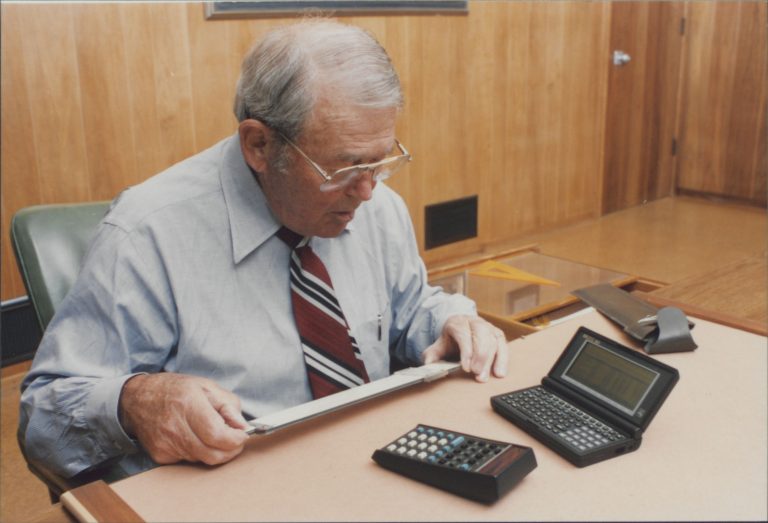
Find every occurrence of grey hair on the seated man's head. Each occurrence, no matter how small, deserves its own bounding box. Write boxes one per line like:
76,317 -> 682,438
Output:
234,19 -> 403,140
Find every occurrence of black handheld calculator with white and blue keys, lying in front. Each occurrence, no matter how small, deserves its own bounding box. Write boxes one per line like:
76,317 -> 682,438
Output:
372,425 -> 536,503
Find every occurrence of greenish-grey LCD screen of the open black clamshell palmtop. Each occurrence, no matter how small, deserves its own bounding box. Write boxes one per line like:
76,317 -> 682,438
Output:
563,341 -> 659,416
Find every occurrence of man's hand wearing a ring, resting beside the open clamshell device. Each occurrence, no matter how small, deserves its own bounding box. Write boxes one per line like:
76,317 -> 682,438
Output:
422,315 -> 509,382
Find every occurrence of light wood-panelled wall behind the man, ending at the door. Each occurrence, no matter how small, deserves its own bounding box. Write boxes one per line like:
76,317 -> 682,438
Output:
0,1 -> 608,299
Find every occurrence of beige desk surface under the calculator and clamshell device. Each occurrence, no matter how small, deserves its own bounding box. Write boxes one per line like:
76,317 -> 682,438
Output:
113,313 -> 768,521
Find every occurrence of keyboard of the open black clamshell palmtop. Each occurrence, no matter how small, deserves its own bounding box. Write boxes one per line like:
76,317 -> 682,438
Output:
501,387 -> 626,452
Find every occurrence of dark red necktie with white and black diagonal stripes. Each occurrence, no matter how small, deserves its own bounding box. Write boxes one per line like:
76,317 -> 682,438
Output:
277,227 -> 370,399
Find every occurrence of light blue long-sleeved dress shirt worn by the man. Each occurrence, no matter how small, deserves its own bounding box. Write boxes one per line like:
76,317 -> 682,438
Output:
19,135 -> 475,476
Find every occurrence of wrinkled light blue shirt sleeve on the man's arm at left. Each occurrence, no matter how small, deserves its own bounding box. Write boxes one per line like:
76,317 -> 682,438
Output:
19,219 -> 175,477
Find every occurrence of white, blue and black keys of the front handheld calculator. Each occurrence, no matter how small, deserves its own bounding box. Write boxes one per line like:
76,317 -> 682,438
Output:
385,425 -> 509,471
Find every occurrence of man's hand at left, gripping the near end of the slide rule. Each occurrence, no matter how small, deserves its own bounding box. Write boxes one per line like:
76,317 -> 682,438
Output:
120,373 -> 248,465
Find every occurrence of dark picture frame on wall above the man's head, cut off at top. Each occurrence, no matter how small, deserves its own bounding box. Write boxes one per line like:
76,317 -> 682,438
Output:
204,0 -> 469,20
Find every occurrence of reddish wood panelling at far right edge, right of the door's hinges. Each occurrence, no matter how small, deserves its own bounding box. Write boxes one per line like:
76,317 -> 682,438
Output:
677,2 -> 768,204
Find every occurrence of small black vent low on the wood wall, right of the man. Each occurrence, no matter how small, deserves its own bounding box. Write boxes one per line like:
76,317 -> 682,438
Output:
424,195 -> 477,249
